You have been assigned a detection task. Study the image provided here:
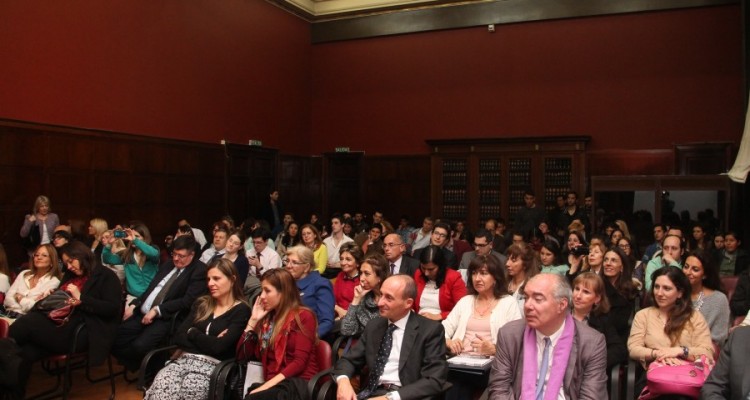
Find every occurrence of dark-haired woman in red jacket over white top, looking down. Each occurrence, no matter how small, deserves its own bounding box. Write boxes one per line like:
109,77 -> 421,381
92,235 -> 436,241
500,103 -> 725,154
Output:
414,245 -> 466,321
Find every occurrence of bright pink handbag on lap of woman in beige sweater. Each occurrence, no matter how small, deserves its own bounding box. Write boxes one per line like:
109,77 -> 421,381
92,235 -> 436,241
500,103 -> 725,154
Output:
638,356 -> 713,400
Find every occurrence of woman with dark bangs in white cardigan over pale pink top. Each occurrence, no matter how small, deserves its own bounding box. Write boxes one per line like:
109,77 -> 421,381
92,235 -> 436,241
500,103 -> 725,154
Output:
443,255 -> 523,356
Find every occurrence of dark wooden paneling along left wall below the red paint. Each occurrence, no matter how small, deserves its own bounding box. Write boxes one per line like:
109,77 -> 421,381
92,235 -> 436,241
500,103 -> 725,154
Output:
0,120 -> 224,265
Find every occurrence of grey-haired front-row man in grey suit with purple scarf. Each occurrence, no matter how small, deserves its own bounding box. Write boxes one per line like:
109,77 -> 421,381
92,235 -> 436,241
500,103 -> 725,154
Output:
489,274 -> 607,400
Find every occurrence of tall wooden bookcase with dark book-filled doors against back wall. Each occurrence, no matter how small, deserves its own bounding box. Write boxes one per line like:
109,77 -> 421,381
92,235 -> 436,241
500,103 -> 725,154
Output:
427,136 -> 590,228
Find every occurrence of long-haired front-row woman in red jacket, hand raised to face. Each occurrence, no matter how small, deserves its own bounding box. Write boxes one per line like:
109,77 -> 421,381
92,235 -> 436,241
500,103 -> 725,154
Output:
237,268 -> 318,400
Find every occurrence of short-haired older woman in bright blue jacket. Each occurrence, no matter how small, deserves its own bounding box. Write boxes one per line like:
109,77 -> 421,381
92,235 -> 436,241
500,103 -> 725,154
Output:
284,245 -> 335,337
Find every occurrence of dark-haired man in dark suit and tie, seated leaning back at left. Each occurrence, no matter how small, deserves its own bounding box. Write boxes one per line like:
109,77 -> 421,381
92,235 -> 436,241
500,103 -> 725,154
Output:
112,235 -> 207,371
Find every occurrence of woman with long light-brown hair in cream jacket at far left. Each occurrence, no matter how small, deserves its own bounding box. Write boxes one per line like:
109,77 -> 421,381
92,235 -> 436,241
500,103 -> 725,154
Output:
0,243 -> 62,314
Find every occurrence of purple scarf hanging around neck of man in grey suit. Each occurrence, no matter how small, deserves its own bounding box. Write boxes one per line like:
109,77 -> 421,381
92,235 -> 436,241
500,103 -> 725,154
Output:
521,314 -> 575,400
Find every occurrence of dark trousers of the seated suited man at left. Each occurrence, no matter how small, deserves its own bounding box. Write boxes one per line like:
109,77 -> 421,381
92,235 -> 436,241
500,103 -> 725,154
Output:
112,310 -> 172,371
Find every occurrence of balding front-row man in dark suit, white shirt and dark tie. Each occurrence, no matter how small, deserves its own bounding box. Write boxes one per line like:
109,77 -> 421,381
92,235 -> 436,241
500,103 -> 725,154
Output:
333,275 -> 448,400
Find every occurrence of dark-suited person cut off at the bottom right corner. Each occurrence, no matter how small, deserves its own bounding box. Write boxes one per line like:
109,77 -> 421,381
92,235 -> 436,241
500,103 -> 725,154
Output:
701,326 -> 750,400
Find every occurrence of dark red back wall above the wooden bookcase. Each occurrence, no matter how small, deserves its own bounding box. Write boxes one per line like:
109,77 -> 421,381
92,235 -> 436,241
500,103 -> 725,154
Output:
311,5 -> 744,156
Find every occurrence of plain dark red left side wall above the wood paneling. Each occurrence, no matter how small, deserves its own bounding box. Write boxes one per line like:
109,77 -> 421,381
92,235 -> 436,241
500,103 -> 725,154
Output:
0,0 -> 311,154
